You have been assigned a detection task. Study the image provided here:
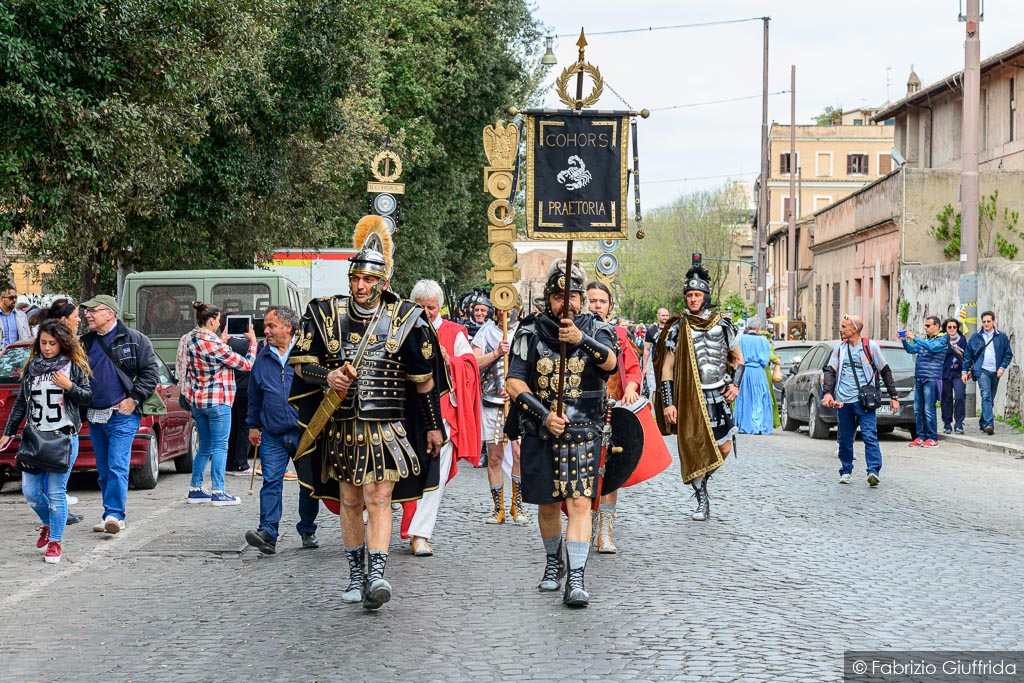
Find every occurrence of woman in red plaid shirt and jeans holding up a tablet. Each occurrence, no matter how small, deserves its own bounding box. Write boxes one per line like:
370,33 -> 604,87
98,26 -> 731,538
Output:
183,301 -> 256,506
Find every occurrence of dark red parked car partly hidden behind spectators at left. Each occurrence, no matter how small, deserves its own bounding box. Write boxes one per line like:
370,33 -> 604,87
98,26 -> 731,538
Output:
0,341 -> 199,488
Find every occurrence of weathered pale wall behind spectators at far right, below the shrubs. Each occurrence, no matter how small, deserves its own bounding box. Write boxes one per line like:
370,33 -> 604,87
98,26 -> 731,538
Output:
900,258 -> 1024,417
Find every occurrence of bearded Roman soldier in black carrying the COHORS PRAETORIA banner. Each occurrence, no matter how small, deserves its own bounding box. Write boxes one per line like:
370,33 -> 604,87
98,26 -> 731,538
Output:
506,259 -> 620,607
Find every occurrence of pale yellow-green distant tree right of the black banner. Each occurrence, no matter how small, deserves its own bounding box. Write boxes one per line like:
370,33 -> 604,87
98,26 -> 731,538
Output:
616,183 -> 750,321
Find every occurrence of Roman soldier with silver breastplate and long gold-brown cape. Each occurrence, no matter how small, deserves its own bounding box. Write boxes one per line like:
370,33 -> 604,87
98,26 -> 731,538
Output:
654,265 -> 743,521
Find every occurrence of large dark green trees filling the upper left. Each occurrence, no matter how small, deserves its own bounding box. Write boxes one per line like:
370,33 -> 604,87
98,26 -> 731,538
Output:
0,0 -> 540,295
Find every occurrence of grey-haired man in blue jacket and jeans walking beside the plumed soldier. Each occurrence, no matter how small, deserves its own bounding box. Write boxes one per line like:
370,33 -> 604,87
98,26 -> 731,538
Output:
246,306 -> 319,555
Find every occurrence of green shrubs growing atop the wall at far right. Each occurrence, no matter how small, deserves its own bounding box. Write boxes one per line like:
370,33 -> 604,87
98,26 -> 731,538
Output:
928,189 -> 1024,260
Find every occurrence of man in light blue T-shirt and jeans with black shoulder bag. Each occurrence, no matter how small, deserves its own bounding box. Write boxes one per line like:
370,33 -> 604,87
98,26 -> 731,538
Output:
821,315 -> 899,486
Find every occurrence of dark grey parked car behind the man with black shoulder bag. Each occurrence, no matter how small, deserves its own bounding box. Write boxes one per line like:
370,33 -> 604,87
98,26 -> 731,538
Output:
779,341 -> 918,438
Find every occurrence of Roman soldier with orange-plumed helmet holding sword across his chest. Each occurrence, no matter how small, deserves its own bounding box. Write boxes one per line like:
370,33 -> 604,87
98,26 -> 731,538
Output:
289,216 -> 451,609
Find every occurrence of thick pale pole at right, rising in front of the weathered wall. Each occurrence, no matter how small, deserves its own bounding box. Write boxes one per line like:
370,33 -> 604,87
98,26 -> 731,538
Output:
959,0 -> 981,327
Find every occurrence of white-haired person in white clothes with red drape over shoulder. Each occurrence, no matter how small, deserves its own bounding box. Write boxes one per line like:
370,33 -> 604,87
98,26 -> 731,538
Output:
400,280 -> 480,557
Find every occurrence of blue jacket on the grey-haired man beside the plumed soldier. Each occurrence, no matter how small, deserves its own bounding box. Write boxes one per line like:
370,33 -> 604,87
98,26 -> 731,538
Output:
246,340 -> 299,435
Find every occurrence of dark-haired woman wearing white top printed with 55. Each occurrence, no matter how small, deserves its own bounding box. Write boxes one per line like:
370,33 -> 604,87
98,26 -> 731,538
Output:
0,321 -> 92,564
